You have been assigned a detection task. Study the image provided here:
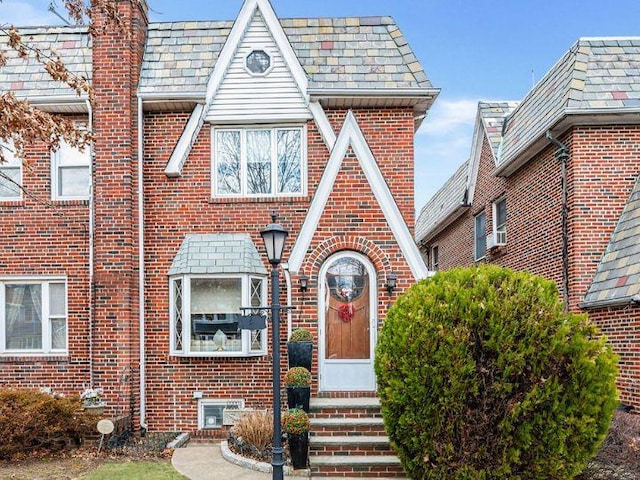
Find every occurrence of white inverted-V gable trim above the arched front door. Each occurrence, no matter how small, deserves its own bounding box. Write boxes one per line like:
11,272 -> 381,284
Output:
289,110 -> 429,279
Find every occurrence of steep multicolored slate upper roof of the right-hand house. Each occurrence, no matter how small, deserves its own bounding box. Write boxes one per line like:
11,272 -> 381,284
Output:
498,37 -> 640,167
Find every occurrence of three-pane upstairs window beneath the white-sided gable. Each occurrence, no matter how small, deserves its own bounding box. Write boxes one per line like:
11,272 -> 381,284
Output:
213,127 -> 305,197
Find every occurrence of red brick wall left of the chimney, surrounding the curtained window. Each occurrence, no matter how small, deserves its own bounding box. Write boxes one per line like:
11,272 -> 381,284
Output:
0,139 -> 89,395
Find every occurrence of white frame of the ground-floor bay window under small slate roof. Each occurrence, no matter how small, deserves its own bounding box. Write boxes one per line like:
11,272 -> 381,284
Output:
169,273 -> 267,357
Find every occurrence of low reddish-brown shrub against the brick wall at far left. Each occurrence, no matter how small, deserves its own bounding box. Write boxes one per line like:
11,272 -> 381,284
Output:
0,388 -> 96,460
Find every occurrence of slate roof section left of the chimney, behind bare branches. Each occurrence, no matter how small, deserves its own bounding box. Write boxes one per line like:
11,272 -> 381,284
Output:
0,27 -> 91,97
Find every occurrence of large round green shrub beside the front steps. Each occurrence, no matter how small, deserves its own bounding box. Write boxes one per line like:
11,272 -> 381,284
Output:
375,266 -> 616,480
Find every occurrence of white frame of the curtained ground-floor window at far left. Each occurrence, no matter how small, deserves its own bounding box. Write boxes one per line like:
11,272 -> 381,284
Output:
0,277 -> 69,357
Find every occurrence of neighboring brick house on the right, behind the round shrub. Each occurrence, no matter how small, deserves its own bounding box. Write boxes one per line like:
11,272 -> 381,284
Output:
416,38 -> 640,408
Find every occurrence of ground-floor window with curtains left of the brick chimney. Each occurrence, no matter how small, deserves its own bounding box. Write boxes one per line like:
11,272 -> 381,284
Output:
0,278 -> 67,355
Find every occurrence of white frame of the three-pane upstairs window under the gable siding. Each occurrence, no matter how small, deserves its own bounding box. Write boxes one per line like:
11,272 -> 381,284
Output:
211,124 -> 307,198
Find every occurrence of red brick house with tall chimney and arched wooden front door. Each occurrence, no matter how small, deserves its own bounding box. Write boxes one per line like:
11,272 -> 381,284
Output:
0,0 -> 438,462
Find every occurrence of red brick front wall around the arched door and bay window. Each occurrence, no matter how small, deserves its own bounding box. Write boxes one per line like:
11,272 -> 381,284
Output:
145,109 -> 414,430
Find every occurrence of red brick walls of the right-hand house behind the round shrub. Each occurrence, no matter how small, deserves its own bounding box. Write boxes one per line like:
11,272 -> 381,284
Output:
422,126 -> 640,407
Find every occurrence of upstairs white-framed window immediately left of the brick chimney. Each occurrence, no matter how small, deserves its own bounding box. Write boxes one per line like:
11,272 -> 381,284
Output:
51,140 -> 91,200
